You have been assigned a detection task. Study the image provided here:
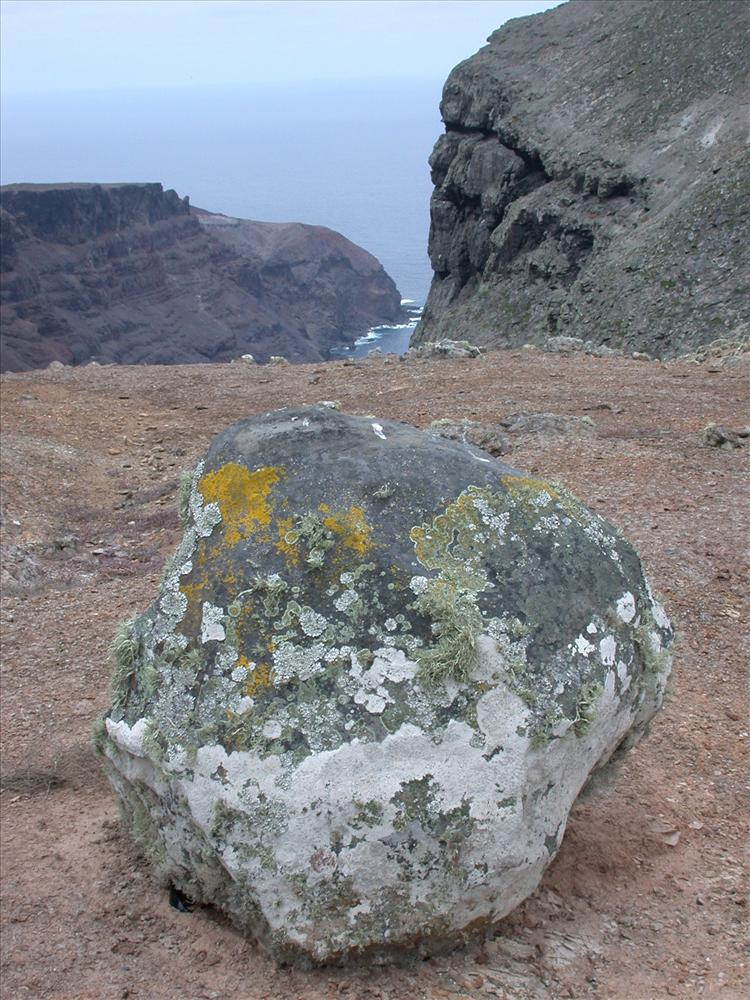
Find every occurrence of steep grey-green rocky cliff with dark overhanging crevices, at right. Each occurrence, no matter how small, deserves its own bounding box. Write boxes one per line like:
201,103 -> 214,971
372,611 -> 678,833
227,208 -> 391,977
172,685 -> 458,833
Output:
413,0 -> 750,356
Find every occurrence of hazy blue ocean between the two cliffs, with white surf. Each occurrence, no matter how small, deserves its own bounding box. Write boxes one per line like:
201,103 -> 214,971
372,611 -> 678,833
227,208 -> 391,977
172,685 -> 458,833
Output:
0,80 -> 442,354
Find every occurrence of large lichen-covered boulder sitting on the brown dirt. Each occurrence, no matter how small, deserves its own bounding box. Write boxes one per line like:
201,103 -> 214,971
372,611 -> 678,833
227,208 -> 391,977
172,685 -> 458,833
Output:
95,407 -> 672,963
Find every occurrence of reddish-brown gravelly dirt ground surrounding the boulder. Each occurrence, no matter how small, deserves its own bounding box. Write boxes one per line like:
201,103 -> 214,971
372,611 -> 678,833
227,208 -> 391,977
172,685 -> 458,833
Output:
0,352 -> 750,1000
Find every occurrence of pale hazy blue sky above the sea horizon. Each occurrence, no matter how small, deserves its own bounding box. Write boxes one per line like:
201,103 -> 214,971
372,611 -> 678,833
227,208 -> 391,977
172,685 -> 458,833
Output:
0,0 -> 559,97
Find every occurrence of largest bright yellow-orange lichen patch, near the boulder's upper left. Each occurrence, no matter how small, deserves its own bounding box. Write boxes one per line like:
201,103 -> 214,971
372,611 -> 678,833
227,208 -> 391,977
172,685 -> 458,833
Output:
198,462 -> 283,546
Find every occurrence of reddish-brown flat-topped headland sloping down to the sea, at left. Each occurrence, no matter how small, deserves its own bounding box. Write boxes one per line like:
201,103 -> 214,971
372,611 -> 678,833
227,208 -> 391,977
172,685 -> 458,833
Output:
0,184 -> 401,371
